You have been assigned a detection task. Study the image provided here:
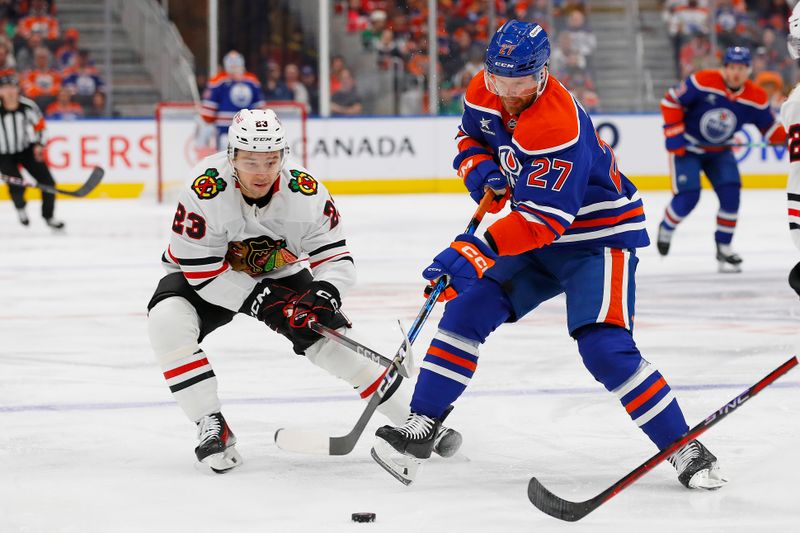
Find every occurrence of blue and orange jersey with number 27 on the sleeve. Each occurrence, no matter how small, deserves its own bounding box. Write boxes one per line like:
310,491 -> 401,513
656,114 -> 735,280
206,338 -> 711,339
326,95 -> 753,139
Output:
453,71 -> 650,255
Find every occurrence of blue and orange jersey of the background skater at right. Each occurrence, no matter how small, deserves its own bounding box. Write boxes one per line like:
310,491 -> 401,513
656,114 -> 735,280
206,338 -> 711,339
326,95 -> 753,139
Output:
661,70 -> 786,154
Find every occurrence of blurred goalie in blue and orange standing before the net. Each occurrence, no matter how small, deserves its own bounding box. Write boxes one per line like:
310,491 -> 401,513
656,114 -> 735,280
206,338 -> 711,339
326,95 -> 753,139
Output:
198,50 -> 266,151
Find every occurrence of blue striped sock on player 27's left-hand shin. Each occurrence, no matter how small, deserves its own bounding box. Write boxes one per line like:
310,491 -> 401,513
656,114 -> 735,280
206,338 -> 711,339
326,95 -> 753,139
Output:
411,329 -> 479,418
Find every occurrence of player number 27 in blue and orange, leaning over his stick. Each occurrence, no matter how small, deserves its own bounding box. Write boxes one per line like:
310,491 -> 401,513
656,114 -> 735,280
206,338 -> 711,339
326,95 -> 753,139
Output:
374,20 -> 724,489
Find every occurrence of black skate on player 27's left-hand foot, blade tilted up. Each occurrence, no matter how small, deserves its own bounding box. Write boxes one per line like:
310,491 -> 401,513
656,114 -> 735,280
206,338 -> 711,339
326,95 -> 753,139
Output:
371,407 -> 450,485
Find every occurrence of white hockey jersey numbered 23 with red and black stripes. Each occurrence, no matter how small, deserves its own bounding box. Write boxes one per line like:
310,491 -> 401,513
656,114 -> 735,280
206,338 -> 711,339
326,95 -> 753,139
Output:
161,152 -> 356,311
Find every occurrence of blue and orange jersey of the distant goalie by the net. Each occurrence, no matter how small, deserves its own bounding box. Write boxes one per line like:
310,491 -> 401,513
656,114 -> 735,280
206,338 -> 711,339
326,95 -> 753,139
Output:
200,72 -> 266,134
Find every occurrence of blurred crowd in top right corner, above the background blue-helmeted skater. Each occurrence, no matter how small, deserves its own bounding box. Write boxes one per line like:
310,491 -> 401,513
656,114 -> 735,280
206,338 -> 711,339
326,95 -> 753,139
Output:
663,0 -> 798,110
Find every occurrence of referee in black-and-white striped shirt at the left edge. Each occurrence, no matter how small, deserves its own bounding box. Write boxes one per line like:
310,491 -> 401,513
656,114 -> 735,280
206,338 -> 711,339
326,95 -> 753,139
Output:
0,70 -> 64,230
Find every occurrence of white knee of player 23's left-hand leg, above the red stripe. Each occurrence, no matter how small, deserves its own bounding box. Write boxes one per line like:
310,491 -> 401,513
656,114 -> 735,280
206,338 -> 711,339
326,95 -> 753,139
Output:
147,296 -> 200,366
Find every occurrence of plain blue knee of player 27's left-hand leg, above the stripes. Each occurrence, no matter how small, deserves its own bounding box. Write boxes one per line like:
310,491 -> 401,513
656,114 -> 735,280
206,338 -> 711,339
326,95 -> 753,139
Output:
439,277 -> 511,343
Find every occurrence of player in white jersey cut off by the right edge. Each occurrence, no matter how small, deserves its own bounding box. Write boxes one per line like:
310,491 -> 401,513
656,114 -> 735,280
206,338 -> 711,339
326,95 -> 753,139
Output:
781,2 -> 800,295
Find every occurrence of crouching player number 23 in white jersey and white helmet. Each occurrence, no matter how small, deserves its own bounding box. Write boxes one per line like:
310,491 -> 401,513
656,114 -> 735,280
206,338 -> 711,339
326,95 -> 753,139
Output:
148,109 -> 461,473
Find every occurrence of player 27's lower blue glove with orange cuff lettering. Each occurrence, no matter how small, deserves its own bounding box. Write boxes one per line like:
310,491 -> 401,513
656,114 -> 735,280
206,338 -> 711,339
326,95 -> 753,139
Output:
422,234 -> 497,300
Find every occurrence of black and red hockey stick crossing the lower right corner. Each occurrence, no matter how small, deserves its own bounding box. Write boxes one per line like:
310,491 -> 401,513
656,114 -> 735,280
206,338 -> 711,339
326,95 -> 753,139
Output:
528,356 -> 797,522
